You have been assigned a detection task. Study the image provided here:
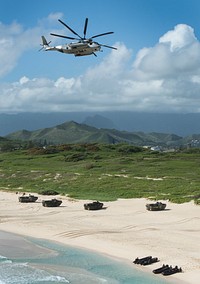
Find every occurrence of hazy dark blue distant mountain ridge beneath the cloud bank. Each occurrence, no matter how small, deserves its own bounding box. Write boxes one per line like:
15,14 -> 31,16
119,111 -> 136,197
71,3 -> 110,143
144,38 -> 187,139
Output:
0,111 -> 200,137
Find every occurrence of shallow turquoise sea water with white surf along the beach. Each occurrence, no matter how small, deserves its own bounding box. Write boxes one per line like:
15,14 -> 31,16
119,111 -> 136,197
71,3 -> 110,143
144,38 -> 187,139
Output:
0,234 -> 167,284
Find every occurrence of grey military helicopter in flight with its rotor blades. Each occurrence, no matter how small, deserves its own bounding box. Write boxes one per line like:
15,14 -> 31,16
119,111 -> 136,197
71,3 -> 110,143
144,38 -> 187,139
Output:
40,18 -> 117,56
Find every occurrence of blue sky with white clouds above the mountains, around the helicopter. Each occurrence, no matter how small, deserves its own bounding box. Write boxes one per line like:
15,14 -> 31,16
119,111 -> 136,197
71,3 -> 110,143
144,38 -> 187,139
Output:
0,0 -> 200,113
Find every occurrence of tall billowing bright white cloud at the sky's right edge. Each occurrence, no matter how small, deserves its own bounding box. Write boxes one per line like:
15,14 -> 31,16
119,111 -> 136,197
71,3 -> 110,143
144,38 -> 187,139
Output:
134,25 -> 200,80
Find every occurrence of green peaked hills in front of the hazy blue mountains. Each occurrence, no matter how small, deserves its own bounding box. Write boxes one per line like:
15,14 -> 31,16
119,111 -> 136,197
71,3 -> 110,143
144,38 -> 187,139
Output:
6,121 -> 182,146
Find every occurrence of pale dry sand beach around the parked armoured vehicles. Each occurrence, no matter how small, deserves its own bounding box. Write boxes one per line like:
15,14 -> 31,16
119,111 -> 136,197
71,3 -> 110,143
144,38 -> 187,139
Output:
0,191 -> 200,284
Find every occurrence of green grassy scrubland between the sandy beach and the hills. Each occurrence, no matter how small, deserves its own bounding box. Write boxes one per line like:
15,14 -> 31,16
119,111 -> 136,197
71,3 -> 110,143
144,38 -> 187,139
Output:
0,144 -> 200,204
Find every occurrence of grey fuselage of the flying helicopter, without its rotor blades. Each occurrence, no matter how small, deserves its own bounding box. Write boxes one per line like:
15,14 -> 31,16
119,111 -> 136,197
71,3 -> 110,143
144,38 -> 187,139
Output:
44,42 -> 101,56
